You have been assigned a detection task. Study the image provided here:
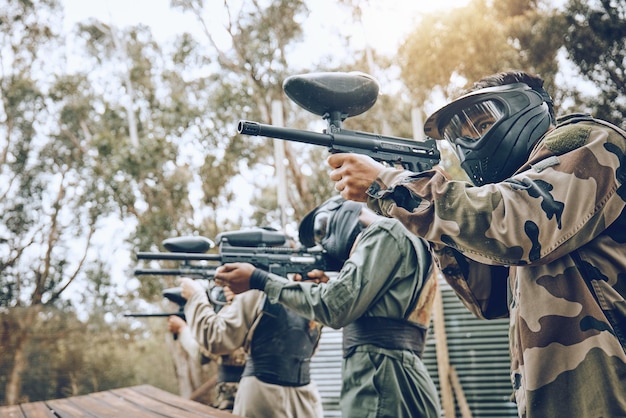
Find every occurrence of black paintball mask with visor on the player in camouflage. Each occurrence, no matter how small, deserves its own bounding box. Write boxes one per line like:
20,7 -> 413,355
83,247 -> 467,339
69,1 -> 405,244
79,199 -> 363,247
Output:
424,83 -> 554,186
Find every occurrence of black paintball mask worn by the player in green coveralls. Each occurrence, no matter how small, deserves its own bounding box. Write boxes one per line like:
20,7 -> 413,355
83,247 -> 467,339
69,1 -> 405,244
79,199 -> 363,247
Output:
298,196 -> 364,271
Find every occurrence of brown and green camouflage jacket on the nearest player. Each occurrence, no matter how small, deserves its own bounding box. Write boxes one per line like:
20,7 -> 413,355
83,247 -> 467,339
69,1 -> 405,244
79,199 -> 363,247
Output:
368,115 -> 626,417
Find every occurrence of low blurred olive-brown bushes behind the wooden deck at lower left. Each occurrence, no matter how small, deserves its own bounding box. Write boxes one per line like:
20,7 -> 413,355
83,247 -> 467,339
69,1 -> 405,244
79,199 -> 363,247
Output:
0,306 -> 178,402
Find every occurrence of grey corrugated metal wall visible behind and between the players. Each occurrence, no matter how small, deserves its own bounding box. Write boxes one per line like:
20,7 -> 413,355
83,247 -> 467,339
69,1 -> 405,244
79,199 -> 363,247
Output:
311,282 -> 517,418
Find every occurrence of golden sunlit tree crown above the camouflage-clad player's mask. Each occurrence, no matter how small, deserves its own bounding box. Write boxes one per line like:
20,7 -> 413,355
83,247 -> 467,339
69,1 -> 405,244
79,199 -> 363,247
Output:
399,0 -> 563,108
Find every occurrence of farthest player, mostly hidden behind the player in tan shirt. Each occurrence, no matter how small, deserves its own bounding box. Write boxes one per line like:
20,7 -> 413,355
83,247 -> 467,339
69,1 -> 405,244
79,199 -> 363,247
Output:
168,286 -> 246,412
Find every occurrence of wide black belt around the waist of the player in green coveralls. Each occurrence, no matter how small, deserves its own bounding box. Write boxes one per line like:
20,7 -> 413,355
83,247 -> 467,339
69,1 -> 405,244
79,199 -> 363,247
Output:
343,316 -> 427,357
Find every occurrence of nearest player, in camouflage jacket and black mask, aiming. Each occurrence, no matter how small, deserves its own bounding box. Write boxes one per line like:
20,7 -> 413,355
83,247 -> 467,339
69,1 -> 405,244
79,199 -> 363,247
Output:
328,71 -> 626,417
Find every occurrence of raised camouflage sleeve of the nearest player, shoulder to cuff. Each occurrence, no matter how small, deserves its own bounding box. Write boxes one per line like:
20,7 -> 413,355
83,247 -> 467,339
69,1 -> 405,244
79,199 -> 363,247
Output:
368,123 -> 626,265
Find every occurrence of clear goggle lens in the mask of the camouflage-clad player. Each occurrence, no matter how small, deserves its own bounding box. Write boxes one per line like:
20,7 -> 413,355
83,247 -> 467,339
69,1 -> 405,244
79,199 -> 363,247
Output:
442,100 -> 504,143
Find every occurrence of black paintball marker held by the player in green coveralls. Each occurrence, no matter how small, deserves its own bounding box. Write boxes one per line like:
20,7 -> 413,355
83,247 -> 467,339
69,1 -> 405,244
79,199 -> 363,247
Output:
137,228 -> 326,278
